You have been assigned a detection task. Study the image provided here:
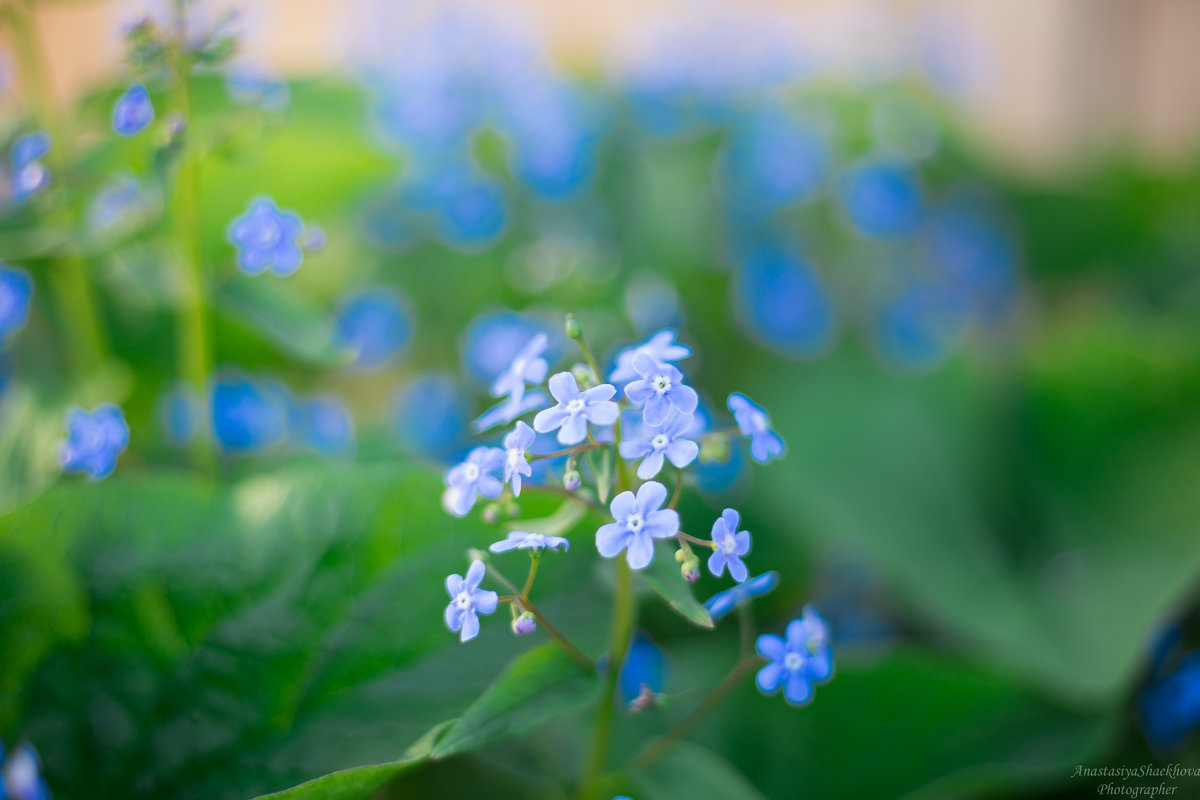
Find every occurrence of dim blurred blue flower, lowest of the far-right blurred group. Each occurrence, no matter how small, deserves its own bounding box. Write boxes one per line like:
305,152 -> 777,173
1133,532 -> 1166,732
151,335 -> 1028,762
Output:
872,282 -> 966,369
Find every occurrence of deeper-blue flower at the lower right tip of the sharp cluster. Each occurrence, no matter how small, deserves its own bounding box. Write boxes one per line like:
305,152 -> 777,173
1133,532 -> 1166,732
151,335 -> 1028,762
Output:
755,606 -> 833,705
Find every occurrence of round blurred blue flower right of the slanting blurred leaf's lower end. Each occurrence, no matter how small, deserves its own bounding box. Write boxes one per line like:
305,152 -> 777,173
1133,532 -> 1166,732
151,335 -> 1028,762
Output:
334,287 -> 413,369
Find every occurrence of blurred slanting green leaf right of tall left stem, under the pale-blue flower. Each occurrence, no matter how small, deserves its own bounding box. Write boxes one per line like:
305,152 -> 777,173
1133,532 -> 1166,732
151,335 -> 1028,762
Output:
214,276 -> 349,366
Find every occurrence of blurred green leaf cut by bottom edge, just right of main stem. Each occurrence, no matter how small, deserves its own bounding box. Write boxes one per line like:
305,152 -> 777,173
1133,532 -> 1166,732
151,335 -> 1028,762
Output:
632,741 -> 767,800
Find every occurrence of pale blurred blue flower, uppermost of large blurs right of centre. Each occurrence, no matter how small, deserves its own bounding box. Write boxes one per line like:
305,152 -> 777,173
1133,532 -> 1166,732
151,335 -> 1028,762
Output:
720,106 -> 829,216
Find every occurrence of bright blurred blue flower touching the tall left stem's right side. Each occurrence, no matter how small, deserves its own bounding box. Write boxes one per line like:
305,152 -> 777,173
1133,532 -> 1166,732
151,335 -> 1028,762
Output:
210,372 -> 292,453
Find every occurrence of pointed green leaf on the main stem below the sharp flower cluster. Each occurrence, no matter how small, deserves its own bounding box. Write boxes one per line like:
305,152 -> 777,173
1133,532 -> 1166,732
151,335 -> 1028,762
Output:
432,642 -> 600,758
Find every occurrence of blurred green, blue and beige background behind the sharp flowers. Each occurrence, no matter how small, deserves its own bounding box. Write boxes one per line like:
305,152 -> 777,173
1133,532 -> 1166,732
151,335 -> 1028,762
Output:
0,0 -> 1200,799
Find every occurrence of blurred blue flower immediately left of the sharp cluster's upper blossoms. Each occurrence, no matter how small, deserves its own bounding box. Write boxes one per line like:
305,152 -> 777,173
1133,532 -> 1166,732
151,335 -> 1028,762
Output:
392,373 -> 469,457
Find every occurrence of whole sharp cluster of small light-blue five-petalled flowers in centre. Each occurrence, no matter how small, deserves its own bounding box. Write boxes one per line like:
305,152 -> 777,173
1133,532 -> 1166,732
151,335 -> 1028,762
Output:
443,318 -> 833,704
